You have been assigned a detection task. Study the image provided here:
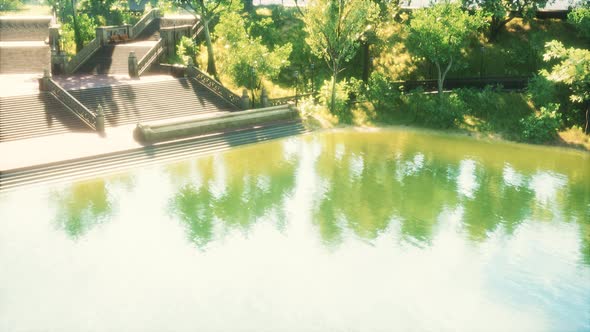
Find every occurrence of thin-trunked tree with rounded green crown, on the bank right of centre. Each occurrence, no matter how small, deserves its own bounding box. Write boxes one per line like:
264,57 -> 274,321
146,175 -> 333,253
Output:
406,2 -> 485,100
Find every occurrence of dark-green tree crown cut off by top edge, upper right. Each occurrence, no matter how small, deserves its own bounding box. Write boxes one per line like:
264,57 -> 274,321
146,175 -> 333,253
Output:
463,0 -> 548,38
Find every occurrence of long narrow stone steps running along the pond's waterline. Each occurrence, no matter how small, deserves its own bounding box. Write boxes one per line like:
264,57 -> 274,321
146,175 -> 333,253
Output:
0,121 -> 308,190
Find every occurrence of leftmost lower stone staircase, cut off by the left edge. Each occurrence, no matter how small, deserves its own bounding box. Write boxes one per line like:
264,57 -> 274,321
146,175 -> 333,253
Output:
0,92 -> 91,142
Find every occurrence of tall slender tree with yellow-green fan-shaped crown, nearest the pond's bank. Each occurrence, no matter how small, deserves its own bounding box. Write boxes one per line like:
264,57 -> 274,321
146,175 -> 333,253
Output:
301,0 -> 379,112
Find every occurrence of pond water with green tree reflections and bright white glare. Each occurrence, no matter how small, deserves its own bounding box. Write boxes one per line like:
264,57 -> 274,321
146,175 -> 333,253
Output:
0,130 -> 590,332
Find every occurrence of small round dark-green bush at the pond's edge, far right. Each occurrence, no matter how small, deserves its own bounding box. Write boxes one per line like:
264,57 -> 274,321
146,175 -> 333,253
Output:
520,104 -> 561,143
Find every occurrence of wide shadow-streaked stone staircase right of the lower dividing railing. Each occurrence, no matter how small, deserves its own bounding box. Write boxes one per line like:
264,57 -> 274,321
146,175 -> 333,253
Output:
68,78 -> 238,127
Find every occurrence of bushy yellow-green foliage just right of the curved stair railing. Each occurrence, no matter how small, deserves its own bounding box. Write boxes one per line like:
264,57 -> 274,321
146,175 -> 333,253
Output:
215,12 -> 292,90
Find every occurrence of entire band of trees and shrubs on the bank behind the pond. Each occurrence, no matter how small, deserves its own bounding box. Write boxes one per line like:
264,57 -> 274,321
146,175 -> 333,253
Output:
0,0 -> 590,149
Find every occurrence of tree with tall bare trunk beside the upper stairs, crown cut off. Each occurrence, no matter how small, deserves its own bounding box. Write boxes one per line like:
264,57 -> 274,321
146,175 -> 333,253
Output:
174,0 -> 237,81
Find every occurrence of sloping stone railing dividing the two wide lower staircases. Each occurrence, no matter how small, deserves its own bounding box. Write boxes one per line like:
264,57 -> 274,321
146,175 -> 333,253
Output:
41,75 -> 104,132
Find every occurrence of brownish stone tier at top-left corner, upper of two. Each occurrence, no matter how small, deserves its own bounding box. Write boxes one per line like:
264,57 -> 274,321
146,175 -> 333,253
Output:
0,16 -> 52,41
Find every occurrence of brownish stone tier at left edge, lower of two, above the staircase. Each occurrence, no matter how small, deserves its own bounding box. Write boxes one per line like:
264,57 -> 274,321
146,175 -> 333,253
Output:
0,42 -> 51,74
